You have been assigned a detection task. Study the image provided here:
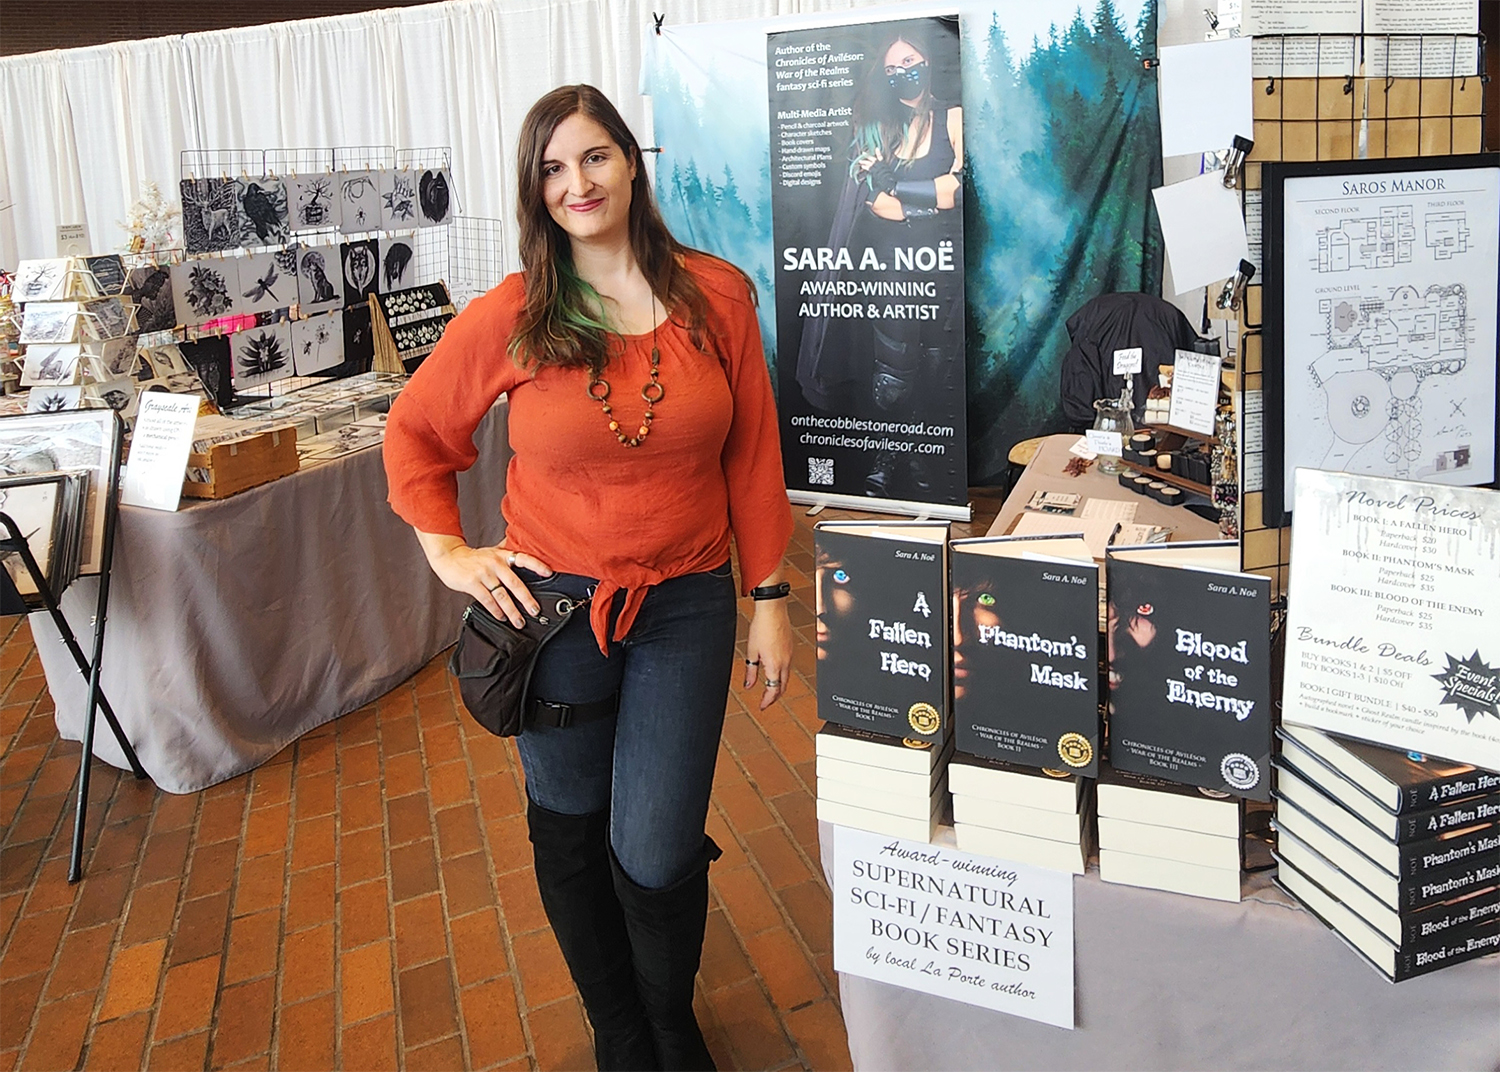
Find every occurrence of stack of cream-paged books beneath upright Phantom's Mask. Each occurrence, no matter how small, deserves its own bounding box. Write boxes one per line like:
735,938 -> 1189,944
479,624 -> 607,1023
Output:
948,754 -> 1094,874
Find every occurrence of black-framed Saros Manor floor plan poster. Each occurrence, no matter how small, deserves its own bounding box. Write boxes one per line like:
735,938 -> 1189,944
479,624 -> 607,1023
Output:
1263,153 -> 1500,526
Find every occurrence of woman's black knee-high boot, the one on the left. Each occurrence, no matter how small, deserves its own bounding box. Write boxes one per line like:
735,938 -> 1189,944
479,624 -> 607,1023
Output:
527,798 -> 662,1072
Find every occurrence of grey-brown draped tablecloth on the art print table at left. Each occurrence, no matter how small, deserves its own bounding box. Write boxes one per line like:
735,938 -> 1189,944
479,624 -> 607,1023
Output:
32,400 -> 510,793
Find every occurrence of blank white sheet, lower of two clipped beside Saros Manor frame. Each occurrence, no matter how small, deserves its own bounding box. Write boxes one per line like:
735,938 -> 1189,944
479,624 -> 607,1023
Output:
1151,171 -> 1250,294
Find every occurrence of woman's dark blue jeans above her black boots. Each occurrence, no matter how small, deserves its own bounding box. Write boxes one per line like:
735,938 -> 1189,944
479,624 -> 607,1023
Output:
516,562 -> 737,889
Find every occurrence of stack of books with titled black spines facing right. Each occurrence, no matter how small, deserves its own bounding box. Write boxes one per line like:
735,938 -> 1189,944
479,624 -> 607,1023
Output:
1277,724 -> 1500,982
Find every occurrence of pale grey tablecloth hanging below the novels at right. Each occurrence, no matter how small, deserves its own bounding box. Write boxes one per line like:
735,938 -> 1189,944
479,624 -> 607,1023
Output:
819,823 -> 1500,1069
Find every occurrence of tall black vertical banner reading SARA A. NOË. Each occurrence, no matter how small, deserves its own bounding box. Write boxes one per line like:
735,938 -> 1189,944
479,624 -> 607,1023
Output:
767,16 -> 969,519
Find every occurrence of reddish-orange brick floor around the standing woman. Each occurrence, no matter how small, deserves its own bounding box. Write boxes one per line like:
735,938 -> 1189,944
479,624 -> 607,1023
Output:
0,498 -> 999,1072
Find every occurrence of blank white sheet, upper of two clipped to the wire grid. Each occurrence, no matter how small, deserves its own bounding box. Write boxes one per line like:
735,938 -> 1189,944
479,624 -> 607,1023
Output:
1158,37 -> 1254,156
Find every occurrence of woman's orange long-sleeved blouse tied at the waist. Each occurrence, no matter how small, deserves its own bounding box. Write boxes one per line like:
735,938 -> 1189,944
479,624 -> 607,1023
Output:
386,255 -> 792,651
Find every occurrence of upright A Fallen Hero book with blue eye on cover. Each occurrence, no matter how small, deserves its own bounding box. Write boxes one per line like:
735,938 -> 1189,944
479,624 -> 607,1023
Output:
813,522 -> 948,741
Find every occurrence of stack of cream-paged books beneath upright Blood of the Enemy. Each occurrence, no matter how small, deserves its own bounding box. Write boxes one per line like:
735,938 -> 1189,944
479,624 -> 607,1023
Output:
1098,766 -> 1269,901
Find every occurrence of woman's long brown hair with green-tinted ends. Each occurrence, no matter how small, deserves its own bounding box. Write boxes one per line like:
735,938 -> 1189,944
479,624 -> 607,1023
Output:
510,85 -> 749,375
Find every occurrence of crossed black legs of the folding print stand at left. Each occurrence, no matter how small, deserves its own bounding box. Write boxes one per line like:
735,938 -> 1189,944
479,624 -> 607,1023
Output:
0,414 -> 147,882
